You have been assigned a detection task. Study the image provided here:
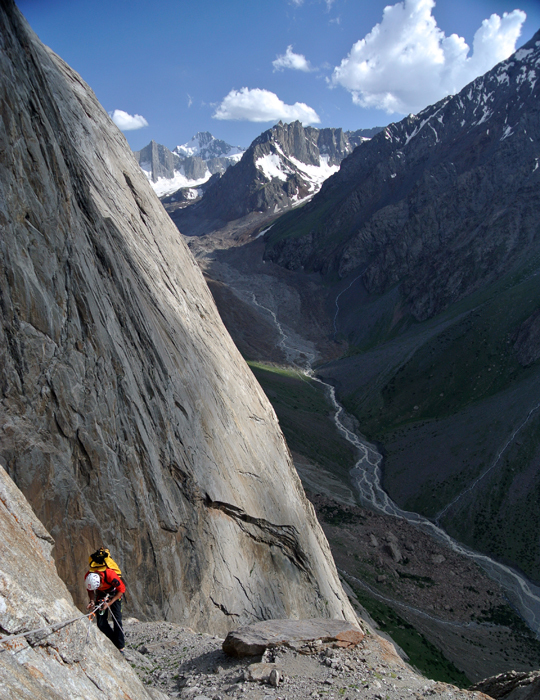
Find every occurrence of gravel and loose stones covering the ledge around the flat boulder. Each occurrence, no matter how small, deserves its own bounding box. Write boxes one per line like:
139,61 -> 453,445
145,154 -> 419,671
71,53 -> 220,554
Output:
124,619 -> 490,700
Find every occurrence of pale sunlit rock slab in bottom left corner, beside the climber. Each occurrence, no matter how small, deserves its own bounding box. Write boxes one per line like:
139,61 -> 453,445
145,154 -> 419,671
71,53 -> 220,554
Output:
0,466 -> 159,700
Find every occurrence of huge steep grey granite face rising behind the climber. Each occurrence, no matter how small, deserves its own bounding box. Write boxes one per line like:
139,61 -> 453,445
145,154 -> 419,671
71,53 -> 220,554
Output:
0,1 -> 355,631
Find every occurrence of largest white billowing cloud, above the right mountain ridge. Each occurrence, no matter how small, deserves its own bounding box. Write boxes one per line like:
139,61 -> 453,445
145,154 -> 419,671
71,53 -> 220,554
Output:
330,0 -> 526,114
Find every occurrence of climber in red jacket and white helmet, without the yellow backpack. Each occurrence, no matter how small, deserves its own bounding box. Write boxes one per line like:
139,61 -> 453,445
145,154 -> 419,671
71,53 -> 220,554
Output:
84,569 -> 126,652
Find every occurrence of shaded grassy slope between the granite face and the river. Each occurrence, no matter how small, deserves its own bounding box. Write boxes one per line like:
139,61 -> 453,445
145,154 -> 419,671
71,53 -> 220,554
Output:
248,362 -> 356,484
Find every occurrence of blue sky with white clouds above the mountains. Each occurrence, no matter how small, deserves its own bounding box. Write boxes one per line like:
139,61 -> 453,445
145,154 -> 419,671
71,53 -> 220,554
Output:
17,0 -> 540,150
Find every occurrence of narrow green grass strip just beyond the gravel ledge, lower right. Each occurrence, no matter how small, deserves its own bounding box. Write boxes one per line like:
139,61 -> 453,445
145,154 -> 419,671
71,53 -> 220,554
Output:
349,582 -> 471,688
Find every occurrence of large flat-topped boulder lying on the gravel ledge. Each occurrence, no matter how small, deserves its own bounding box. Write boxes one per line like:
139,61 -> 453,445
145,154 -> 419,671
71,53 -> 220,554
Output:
223,619 -> 364,656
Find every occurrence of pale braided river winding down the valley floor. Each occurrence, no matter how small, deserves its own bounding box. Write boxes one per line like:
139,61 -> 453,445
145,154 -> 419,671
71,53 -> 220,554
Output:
250,288 -> 540,639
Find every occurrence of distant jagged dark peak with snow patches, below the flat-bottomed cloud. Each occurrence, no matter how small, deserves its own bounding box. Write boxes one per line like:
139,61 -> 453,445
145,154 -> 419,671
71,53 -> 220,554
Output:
170,122 -> 377,236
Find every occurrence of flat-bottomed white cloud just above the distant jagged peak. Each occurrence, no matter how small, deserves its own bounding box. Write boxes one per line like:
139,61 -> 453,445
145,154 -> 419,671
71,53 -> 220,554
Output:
212,88 -> 321,125
